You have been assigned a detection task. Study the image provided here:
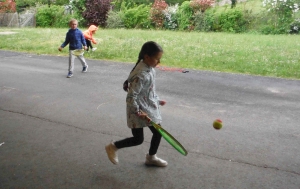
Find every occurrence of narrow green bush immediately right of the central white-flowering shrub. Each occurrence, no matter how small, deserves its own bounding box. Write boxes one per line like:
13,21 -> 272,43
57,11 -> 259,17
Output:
177,1 -> 194,30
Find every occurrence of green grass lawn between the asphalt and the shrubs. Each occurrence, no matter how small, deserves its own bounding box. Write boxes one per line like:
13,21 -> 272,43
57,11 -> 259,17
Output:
0,28 -> 300,79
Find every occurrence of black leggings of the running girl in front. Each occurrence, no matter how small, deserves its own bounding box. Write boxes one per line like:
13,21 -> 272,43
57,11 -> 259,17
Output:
115,126 -> 161,155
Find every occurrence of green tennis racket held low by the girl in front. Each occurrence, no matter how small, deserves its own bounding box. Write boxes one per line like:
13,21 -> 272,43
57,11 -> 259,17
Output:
145,113 -> 188,156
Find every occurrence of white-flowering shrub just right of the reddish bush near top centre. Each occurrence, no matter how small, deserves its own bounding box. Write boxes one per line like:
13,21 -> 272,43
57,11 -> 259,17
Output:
164,4 -> 178,30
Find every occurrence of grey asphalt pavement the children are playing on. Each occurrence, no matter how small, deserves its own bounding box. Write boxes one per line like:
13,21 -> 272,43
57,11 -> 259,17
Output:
0,50 -> 300,189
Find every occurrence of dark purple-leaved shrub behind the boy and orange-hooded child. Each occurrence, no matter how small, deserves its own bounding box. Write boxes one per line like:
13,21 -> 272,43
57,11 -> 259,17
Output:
82,0 -> 111,27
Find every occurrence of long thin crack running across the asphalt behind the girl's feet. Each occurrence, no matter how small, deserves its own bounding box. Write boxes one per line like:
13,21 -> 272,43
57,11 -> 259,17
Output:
0,108 -> 300,176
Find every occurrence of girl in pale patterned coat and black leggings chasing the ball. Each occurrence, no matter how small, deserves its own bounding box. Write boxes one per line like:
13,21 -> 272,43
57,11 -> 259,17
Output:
105,41 -> 168,167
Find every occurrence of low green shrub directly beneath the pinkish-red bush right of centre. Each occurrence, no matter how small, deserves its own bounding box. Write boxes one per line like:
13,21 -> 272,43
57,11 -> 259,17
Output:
194,9 -> 215,32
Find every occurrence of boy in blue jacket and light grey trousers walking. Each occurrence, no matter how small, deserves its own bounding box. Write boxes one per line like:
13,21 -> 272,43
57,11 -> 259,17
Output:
58,19 -> 88,78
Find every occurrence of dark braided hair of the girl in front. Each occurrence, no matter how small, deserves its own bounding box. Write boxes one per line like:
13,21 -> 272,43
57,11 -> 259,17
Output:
131,41 -> 163,72
